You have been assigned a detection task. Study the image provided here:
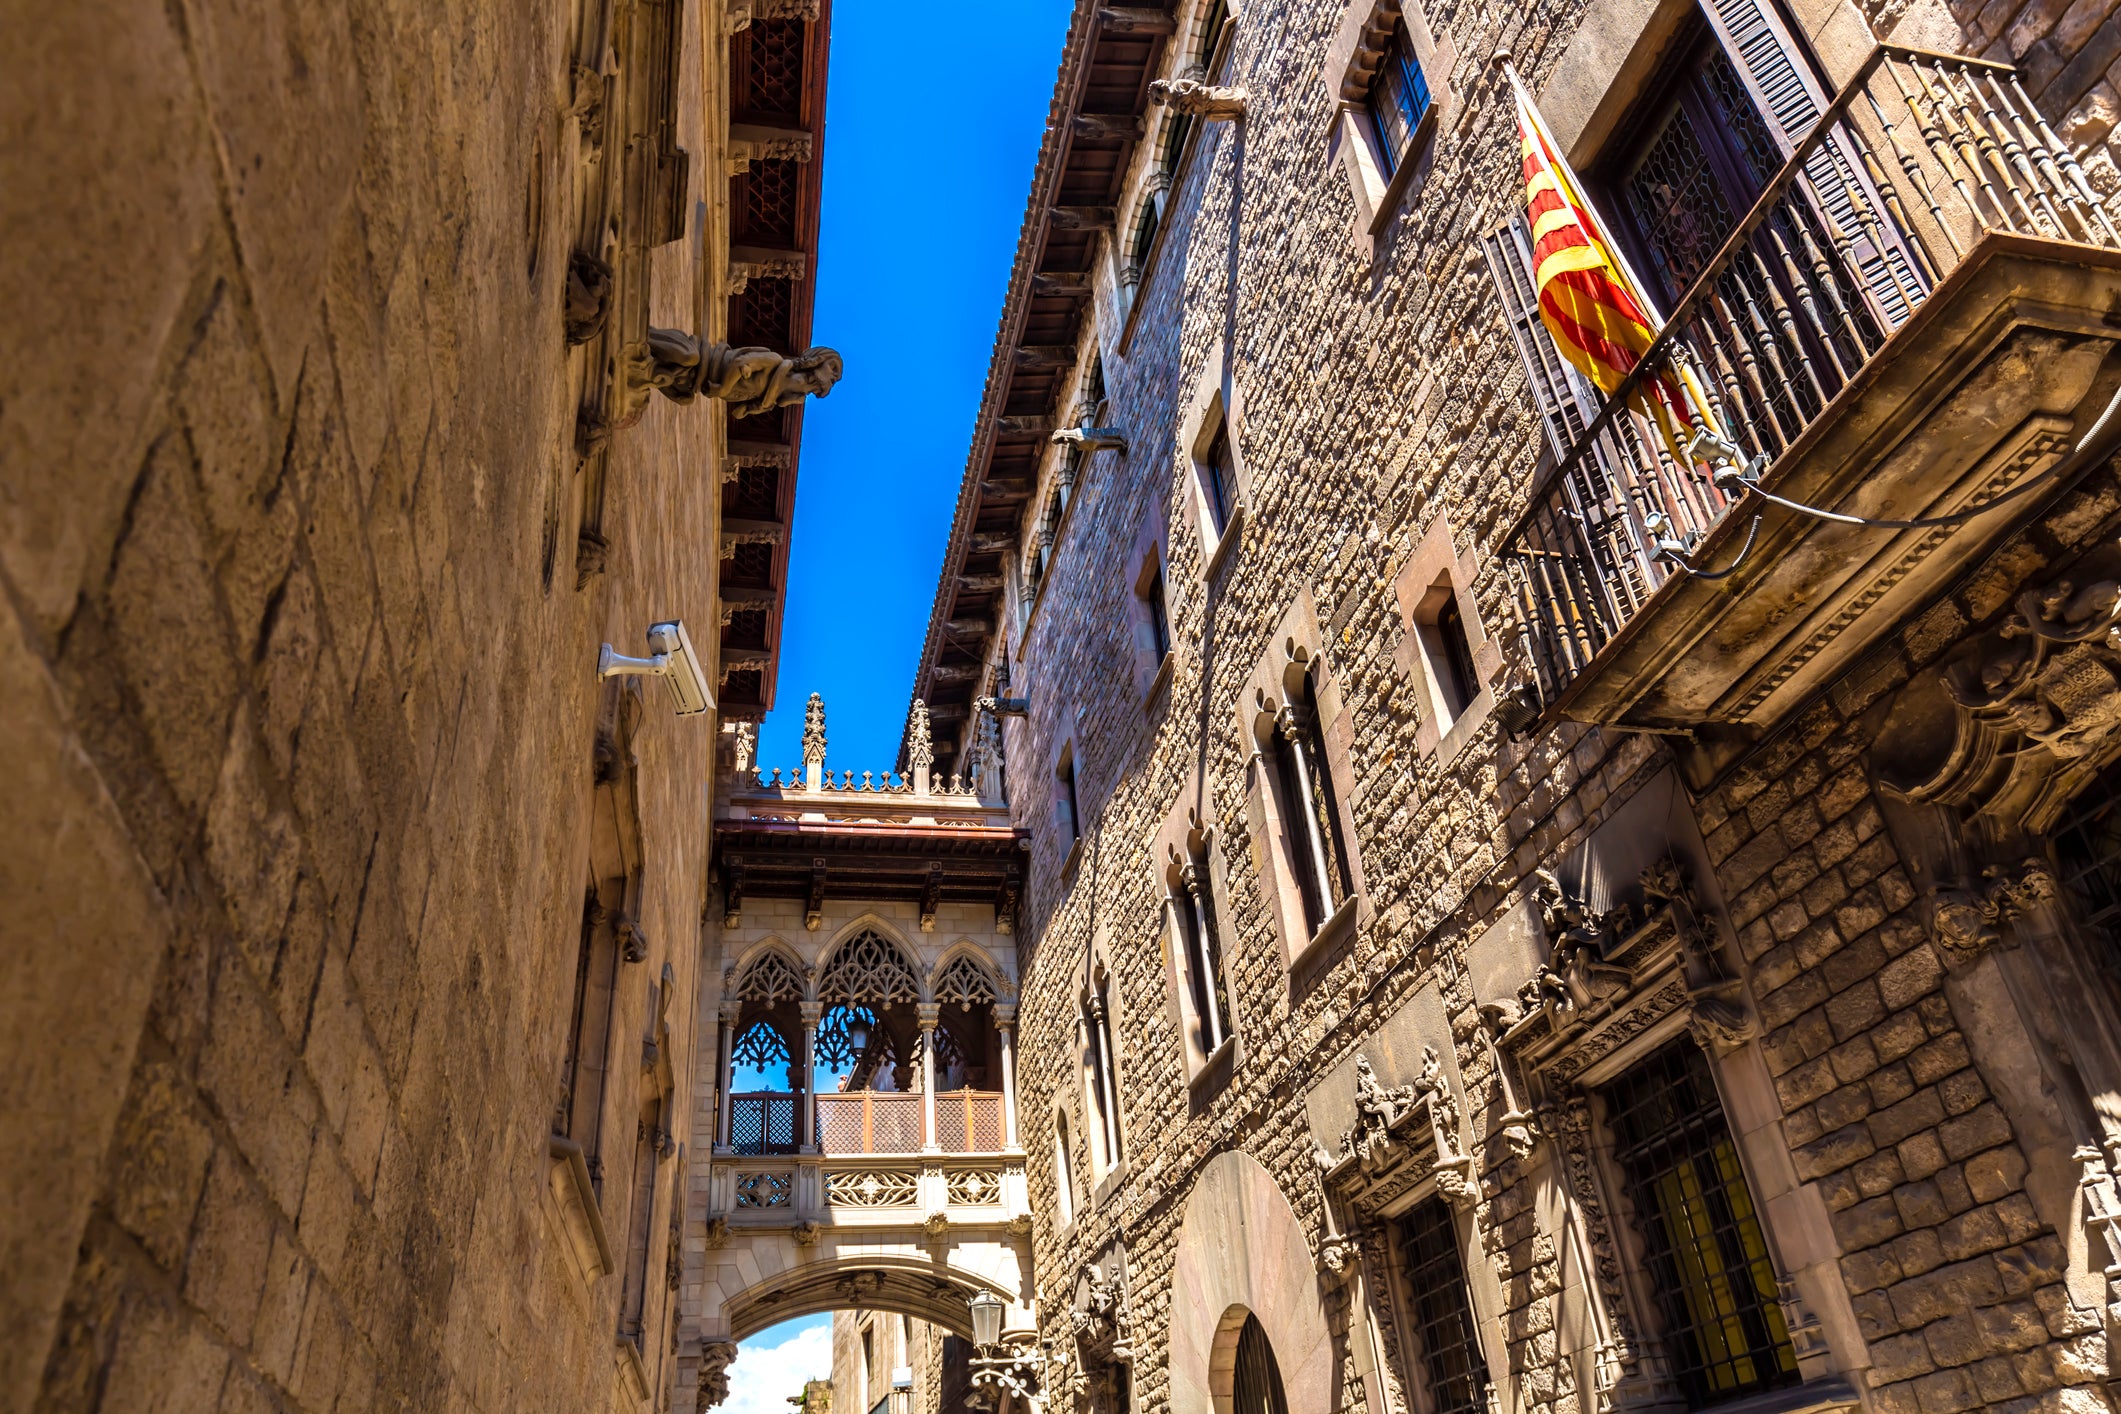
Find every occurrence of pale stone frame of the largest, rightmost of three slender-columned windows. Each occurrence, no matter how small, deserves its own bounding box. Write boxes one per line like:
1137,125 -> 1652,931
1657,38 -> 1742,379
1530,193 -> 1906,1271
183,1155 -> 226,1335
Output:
1234,589 -> 1377,977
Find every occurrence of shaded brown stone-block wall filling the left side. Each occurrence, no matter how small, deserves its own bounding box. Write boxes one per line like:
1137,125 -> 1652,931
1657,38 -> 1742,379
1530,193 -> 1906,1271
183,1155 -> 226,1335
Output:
0,0 -> 715,1410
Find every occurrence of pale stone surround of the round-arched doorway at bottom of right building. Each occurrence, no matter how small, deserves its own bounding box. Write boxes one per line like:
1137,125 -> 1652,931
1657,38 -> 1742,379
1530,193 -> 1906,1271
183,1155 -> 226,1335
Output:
1171,1149 -> 1336,1414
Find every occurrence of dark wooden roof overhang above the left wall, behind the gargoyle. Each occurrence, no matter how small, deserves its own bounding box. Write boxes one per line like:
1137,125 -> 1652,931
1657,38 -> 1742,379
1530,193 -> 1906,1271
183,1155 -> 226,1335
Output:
721,0 -> 831,721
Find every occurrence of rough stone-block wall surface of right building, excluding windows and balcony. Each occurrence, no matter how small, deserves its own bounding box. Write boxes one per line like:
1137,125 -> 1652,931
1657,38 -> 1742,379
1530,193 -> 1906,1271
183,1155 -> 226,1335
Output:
1007,0 -> 2113,1412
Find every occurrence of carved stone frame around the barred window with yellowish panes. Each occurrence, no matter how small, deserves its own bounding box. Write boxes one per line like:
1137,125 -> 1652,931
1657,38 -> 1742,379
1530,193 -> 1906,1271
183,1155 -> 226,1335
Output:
1480,835 -> 1869,1412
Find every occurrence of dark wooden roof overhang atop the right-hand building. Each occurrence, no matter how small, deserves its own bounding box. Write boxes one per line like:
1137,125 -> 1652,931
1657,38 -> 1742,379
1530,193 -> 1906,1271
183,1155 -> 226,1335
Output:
901,0 -> 1177,765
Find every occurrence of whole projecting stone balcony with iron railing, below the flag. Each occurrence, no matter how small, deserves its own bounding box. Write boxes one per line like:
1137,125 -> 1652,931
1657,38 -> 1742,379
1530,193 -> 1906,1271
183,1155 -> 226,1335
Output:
1502,47 -> 2121,727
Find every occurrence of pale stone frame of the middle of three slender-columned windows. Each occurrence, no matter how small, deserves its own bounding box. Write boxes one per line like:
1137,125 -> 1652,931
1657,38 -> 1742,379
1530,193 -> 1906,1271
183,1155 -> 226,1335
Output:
1150,765 -> 1245,1109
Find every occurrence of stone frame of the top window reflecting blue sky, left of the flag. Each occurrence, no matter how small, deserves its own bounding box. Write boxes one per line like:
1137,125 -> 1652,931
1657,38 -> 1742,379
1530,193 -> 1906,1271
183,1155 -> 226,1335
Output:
1321,0 -> 1459,257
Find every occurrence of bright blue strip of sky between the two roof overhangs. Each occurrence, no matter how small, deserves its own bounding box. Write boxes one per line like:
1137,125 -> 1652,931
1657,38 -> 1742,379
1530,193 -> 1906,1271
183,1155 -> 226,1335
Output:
759,0 -> 1071,772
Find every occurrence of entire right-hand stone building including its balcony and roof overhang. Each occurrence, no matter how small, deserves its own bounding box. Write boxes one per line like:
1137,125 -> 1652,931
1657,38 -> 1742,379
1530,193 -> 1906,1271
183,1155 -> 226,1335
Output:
914,0 -> 2121,1414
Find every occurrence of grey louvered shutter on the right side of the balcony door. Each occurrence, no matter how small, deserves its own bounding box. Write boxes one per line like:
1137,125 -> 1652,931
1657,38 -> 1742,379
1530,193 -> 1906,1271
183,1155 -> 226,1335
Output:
1703,0 -> 1917,329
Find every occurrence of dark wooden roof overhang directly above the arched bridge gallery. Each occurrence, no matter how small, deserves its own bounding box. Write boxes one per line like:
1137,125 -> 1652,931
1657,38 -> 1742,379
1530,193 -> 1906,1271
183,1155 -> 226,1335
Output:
715,820 -> 1029,916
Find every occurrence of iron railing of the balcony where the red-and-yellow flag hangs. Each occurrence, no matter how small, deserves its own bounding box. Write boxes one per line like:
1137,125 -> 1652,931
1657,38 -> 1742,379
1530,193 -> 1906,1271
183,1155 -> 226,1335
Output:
1502,45 -> 2121,704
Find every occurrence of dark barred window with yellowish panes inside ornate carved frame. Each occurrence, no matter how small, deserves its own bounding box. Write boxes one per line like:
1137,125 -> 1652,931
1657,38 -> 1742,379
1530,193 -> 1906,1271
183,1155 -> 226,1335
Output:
1606,1039 -> 1796,1410
